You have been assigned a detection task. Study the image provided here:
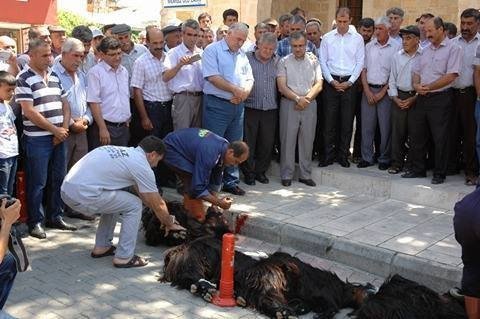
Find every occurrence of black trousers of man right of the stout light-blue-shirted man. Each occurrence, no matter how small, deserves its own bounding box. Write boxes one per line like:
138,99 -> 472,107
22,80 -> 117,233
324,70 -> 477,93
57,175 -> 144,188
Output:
240,107 -> 278,177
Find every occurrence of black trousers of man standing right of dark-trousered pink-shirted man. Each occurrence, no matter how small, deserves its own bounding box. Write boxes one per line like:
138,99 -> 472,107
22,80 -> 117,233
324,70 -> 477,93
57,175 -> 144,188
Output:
448,86 -> 478,176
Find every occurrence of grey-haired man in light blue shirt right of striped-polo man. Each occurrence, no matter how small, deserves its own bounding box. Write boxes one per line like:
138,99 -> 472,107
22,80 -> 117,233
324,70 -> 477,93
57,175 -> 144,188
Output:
52,38 -> 95,220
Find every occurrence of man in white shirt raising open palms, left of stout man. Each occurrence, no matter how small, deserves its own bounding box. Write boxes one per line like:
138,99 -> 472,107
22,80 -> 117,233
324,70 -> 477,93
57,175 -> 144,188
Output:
163,19 -> 204,130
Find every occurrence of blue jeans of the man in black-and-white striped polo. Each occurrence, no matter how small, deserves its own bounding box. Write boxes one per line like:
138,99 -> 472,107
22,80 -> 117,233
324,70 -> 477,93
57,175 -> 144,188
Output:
24,135 -> 67,227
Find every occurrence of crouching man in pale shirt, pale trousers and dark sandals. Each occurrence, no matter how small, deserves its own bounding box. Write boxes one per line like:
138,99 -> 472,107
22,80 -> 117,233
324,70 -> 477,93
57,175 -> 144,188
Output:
61,136 -> 184,268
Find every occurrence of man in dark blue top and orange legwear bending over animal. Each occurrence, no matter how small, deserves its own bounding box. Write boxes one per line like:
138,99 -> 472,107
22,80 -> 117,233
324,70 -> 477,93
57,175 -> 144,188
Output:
163,128 -> 248,222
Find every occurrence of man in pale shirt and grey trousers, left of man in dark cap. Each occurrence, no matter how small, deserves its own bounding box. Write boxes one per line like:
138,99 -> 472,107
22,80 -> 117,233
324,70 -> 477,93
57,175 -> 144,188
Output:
357,16 -> 399,170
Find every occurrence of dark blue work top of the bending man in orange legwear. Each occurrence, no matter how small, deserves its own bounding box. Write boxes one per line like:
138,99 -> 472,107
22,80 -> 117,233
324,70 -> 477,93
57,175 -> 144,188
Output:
163,128 -> 229,198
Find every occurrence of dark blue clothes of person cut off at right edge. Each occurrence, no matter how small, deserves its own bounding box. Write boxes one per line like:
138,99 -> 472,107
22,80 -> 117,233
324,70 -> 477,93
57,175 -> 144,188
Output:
453,188 -> 480,298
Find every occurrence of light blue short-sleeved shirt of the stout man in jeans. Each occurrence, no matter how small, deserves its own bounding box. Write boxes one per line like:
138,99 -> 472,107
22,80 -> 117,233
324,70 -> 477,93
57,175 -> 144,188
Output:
202,39 -> 253,100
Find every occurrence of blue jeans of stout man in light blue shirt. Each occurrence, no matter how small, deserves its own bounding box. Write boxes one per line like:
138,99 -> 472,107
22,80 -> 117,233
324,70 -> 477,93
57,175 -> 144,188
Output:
202,94 -> 244,188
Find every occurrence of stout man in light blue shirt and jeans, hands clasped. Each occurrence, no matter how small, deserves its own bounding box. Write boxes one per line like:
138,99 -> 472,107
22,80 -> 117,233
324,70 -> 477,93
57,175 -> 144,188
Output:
202,23 -> 253,195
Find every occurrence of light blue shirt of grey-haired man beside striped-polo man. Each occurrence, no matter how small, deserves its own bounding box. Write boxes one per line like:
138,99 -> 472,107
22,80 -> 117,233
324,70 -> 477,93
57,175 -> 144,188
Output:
52,60 -> 93,125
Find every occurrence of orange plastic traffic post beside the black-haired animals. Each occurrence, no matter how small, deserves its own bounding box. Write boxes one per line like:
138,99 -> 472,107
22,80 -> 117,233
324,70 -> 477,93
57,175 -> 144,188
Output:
212,233 -> 236,307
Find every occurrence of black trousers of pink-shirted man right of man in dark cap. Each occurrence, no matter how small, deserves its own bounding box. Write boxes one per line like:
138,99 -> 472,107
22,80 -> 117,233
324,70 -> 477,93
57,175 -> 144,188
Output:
408,89 -> 453,178
